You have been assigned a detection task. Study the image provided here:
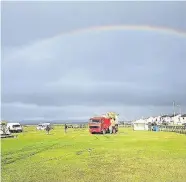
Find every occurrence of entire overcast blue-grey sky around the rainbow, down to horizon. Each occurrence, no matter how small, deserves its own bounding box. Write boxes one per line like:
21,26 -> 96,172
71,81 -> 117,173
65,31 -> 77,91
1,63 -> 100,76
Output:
1,2 -> 186,120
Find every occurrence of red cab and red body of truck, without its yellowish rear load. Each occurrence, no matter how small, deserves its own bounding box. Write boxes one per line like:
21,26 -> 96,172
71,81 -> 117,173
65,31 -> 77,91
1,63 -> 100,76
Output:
88,117 -> 118,134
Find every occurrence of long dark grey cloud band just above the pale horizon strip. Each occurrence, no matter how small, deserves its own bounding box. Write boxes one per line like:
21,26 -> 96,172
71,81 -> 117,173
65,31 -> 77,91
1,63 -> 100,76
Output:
2,90 -> 186,107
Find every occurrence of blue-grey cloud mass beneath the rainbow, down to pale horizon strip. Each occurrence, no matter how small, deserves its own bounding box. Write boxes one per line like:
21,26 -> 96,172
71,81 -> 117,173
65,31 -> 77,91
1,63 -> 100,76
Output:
2,31 -> 186,106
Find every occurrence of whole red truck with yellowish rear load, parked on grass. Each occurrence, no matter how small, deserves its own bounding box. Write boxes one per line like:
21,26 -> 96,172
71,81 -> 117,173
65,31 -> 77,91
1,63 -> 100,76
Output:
88,113 -> 118,134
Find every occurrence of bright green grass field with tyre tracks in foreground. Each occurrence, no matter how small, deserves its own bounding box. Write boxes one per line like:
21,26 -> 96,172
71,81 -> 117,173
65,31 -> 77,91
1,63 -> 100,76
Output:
1,126 -> 186,182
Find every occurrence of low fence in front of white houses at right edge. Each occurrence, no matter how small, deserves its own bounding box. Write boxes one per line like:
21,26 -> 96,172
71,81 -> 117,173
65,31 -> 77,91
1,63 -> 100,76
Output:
158,125 -> 186,135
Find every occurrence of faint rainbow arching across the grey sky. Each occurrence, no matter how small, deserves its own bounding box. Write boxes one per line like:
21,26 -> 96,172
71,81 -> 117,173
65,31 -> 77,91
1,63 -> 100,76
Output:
52,25 -> 186,38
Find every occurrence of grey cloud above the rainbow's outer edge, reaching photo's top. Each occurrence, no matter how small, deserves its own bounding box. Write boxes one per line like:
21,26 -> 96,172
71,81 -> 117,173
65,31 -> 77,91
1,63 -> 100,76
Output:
2,1 -> 186,46
